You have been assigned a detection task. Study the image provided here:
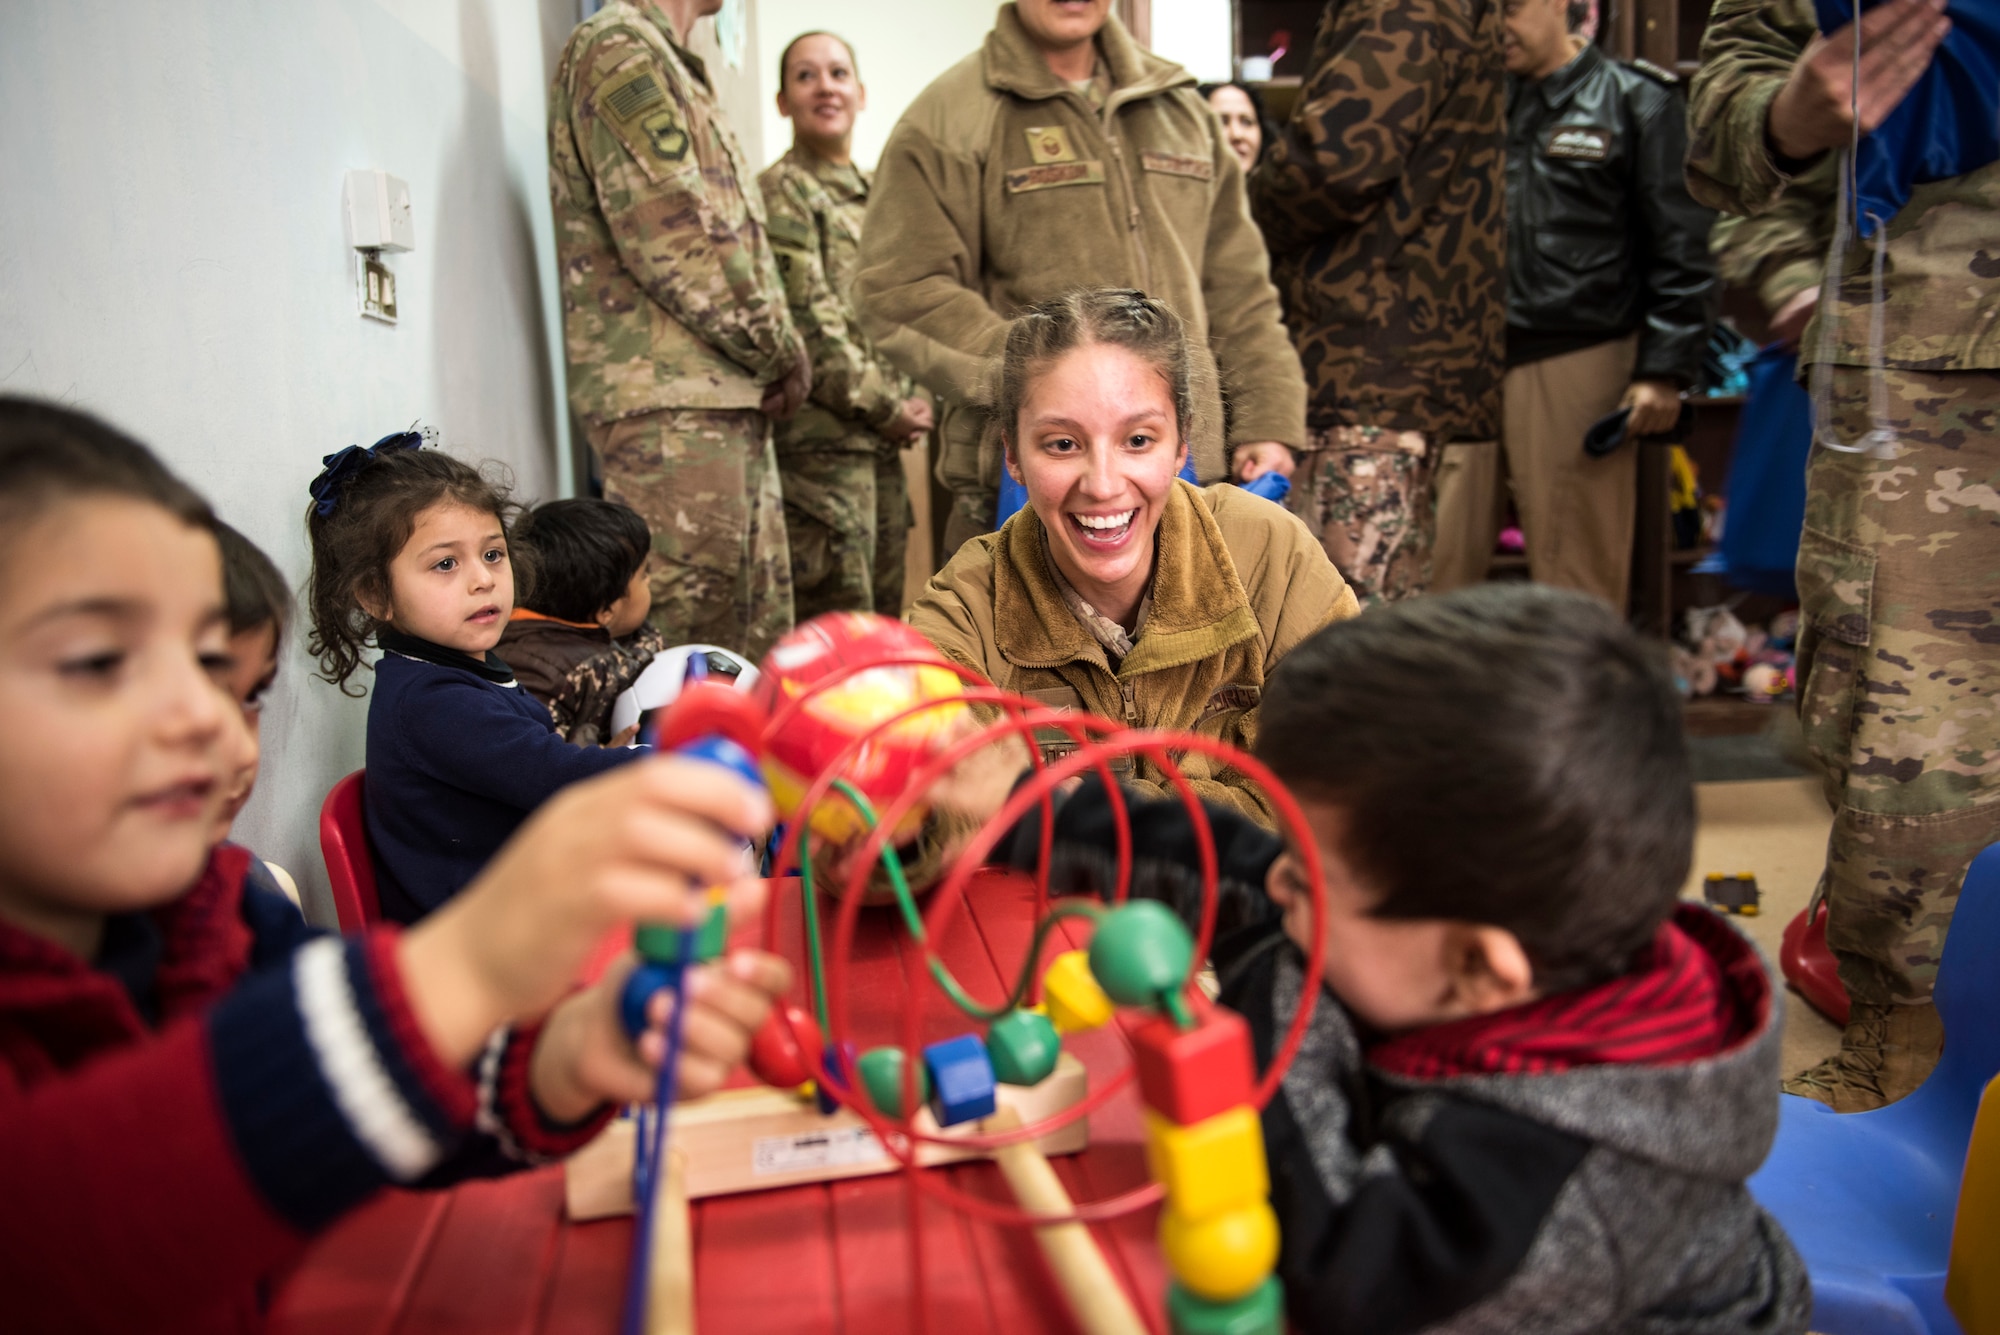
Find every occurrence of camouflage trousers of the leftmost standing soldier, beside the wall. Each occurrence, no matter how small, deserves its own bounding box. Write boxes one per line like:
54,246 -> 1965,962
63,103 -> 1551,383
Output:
590,408 -> 792,660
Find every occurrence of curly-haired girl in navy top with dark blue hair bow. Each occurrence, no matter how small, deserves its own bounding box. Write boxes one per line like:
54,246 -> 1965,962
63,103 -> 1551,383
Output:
306,432 -> 638,923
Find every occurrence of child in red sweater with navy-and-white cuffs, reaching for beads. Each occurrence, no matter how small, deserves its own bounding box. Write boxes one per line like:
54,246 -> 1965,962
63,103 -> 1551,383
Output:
0,398 -> 790,1333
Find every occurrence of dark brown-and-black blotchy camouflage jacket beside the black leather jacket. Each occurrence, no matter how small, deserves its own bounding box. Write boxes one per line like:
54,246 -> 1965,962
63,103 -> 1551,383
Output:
1250,0 -> 1506,440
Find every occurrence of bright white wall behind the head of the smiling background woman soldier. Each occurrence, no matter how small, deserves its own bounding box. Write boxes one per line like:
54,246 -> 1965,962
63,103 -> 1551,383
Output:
752,0 -> 1000,166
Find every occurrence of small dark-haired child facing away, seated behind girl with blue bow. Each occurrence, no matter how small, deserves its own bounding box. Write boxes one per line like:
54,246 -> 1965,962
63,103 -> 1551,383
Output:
500,500 -> 666,745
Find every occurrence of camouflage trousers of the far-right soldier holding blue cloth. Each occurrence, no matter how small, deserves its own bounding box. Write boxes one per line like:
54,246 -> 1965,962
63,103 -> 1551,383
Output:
1798,366 -> 2000,1005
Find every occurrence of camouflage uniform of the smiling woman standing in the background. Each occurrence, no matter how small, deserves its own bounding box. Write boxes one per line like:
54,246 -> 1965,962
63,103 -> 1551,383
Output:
758,148 -> 916,622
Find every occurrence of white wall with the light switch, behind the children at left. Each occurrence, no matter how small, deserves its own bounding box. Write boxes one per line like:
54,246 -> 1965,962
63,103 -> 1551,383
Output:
0,0 -> 576,927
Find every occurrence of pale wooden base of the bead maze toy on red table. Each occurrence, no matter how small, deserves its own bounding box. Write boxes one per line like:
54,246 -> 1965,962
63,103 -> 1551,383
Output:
564,1053 -> 1090,1219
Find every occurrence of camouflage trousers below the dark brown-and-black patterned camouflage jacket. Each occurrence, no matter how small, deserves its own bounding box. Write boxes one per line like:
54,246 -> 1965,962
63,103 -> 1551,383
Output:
1286,426 -> 1438,606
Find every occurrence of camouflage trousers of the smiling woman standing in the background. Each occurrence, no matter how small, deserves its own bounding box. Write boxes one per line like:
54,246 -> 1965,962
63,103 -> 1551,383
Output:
778,446 -> 914,622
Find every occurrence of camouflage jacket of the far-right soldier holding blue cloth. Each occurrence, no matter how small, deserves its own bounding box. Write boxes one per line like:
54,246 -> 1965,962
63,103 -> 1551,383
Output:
1688,0 -> 2000,372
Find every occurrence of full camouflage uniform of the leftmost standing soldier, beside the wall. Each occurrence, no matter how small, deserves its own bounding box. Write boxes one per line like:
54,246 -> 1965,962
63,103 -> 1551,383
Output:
548,0 -> 804,658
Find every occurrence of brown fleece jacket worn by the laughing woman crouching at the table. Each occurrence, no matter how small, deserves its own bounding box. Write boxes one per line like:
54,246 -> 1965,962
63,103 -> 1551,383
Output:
908,473 -> 1360,825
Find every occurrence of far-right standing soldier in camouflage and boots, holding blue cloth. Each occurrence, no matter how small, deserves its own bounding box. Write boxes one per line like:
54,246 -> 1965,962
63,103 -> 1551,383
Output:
1688,0 -> 2000,1111
